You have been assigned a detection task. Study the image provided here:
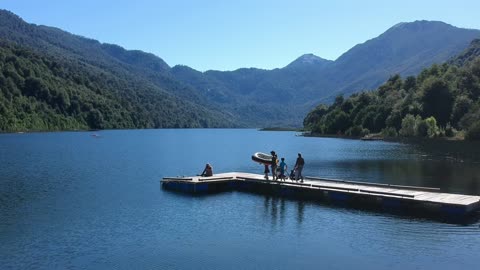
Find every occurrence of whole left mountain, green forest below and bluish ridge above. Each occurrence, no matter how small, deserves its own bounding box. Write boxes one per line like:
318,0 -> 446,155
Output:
0,11 -> 240,131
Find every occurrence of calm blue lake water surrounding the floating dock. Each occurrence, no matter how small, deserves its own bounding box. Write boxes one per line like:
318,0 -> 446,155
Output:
0,129 -> 480,269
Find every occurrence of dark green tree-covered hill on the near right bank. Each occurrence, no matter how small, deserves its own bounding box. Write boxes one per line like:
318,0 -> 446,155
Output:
304,40 -> 480,140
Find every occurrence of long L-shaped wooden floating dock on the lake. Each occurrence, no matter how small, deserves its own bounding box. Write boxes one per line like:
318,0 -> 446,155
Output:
161,172 -> 480,219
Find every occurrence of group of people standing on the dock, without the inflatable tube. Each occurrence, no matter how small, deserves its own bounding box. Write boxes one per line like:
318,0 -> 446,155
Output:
264,151 -> 305,182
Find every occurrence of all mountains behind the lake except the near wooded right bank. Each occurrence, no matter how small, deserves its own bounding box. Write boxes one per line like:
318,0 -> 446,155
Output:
0,11 -> 480,131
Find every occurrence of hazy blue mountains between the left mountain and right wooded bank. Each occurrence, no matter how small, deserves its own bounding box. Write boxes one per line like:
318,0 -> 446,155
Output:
173,21 -> 480,126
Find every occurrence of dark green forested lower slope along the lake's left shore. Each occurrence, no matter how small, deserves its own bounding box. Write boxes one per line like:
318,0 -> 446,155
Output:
0,42 -> 234,132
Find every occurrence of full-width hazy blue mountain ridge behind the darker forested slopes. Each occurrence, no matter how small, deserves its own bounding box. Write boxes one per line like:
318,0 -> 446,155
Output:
0,11 -> 480,130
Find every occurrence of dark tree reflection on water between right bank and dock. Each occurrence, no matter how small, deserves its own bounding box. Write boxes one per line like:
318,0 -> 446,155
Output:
305,141 -> 480,195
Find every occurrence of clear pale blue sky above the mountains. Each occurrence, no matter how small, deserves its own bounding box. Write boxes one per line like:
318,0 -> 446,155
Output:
0,0 -> 480,71
